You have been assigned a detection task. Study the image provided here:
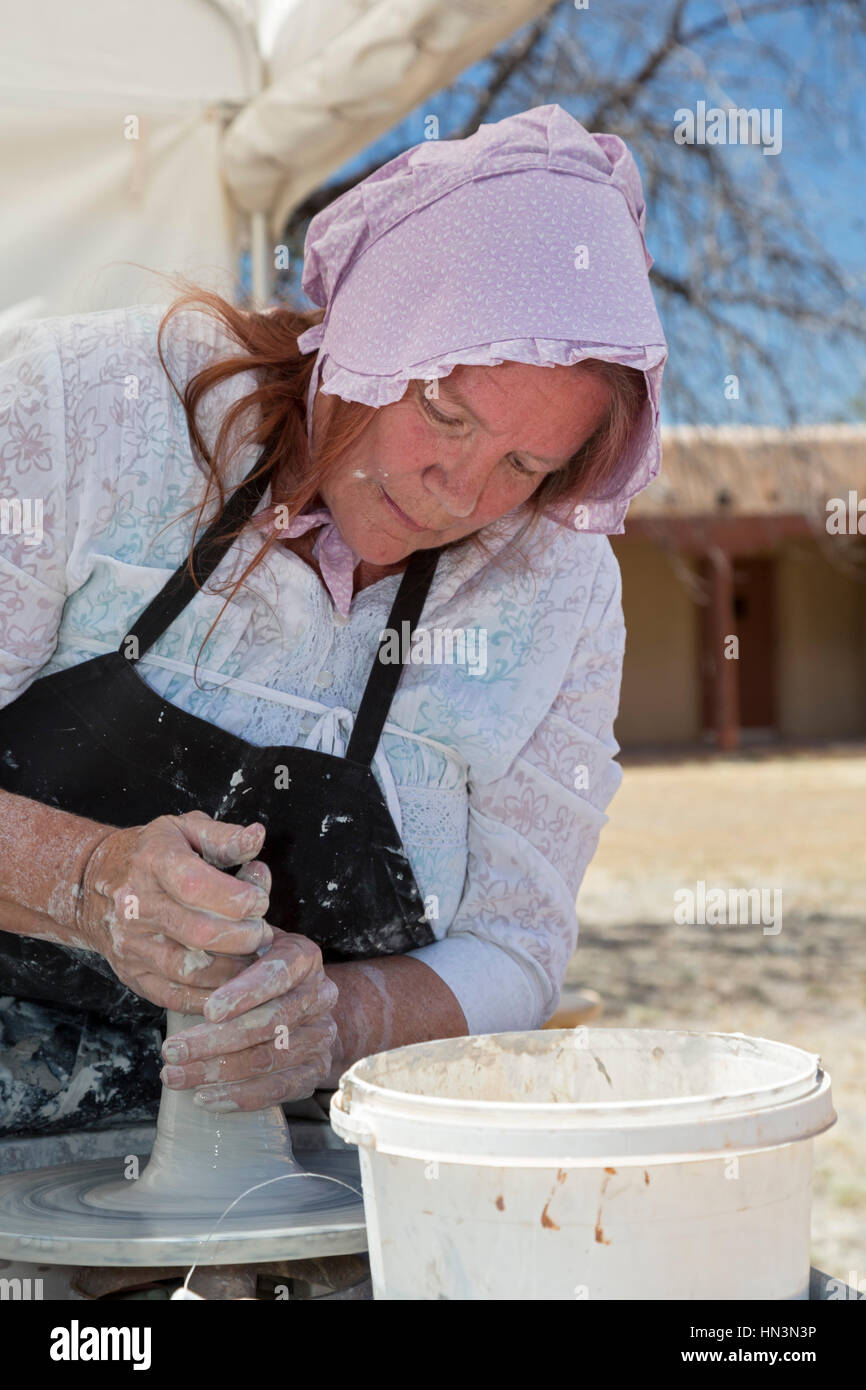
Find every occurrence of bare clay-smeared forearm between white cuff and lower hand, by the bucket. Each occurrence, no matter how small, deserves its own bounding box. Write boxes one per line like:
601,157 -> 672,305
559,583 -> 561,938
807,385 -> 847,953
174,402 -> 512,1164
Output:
325,956 -> 468,1086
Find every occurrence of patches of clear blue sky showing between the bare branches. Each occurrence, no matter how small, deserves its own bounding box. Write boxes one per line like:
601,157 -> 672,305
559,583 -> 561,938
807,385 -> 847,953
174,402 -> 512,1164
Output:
268,0 -> 866,424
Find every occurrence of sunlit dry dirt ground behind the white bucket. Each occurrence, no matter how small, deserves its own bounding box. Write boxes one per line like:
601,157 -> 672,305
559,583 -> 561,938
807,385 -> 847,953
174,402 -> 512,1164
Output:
567,745 -> 866,1291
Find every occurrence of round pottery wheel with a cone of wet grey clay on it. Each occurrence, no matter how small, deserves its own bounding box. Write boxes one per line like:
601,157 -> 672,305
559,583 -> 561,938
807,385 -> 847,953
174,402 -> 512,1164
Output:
0,1013 -> 367,1265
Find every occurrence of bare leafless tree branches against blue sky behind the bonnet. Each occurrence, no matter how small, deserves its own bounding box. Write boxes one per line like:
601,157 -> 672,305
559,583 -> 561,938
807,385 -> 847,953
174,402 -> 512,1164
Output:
280,0 -> 866,420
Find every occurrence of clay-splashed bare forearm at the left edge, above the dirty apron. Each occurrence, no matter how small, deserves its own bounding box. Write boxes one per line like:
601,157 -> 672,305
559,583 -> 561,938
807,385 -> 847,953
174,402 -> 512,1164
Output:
0,791 -> 113,945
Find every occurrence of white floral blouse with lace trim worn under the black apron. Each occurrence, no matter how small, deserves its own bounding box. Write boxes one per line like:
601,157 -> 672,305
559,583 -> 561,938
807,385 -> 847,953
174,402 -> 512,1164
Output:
0,304 -> 626,1033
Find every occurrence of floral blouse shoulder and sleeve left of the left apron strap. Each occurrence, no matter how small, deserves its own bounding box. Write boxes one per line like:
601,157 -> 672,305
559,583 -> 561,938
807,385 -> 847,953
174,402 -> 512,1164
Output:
0,304 -> 257,708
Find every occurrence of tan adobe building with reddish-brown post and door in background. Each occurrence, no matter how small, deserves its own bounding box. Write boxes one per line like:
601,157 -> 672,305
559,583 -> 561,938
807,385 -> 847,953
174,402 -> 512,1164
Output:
612,424 -> 866,751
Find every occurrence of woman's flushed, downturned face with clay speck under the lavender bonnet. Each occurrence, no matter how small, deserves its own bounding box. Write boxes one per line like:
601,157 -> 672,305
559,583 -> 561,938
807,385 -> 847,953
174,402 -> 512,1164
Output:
317,361 -> 609,566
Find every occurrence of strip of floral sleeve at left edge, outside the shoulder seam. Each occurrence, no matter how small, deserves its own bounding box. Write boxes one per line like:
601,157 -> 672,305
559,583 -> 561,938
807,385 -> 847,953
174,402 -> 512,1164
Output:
0,321 -> 75,708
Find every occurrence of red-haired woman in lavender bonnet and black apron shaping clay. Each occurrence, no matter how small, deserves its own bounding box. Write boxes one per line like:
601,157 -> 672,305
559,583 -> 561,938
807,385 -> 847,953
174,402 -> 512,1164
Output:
0,106 -> 666,1129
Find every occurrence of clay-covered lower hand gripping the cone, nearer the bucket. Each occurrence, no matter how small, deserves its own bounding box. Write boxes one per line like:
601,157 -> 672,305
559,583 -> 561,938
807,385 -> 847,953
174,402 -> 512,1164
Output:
161,927 -> 339,1113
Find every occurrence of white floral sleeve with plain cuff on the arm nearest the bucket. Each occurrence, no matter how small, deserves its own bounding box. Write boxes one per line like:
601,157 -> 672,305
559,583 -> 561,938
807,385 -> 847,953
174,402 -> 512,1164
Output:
409,543 -> 626,1034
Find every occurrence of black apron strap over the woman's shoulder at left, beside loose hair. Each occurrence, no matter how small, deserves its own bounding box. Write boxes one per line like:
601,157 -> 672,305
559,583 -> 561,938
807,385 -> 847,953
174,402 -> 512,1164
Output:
118,446 -> 271,662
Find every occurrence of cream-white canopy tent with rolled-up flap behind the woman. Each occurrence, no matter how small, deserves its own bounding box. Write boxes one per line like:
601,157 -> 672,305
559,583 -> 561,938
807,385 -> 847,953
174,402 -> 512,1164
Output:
0,0 -> 552,320
